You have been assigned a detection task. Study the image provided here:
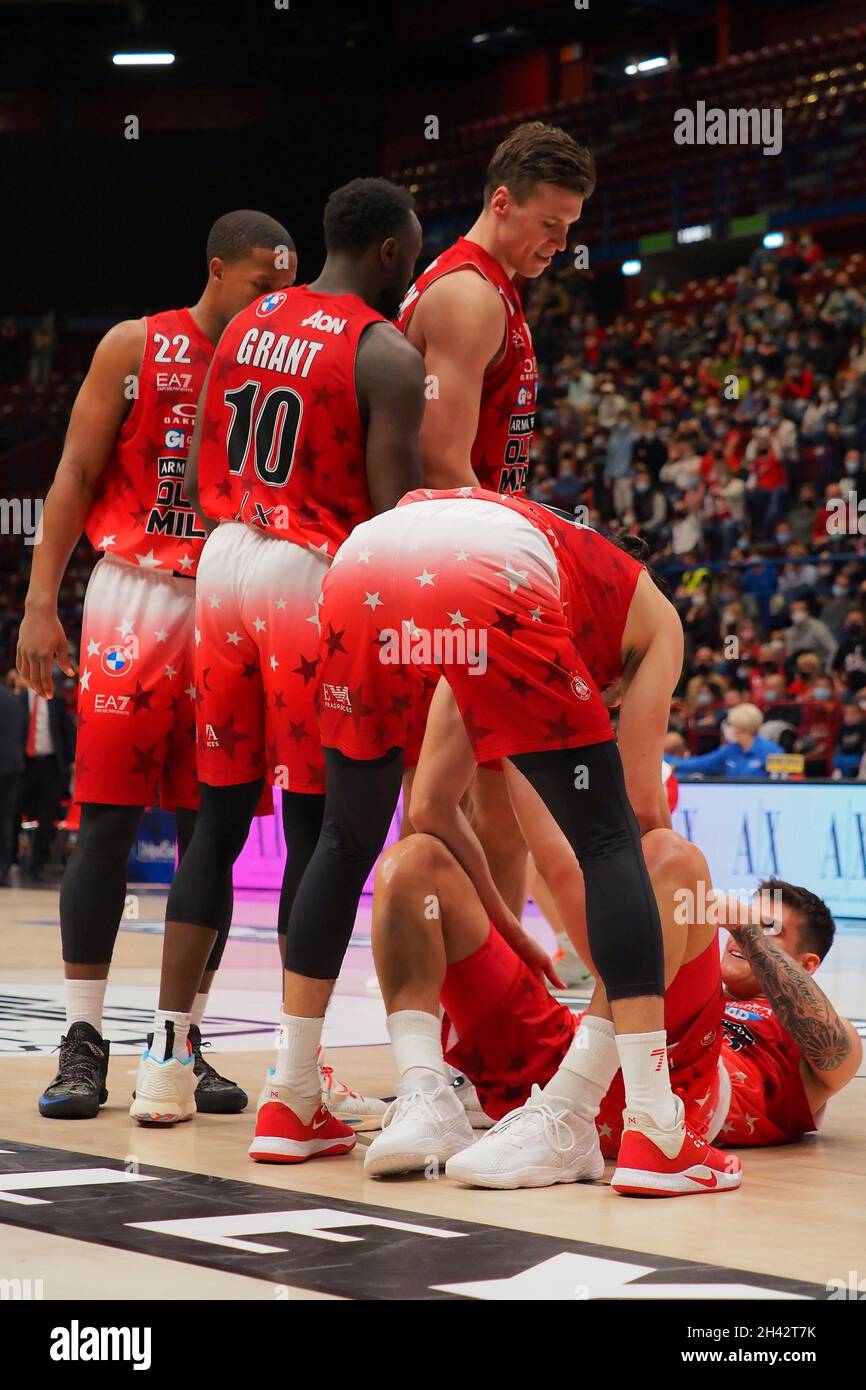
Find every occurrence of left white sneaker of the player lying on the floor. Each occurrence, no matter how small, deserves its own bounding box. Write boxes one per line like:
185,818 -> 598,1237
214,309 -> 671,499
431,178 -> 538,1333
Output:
364,1086 -> 474,1177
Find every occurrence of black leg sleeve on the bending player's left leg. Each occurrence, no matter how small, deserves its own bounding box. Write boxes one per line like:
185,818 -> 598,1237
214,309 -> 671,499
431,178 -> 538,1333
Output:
285,748 -> 403,980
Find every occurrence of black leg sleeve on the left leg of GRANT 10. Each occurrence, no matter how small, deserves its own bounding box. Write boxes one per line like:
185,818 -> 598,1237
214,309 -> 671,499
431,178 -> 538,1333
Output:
165,780 -> 263,934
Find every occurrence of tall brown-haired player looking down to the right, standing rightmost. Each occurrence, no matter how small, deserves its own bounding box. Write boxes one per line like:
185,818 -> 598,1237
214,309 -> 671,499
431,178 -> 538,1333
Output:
398,121 -> 595,915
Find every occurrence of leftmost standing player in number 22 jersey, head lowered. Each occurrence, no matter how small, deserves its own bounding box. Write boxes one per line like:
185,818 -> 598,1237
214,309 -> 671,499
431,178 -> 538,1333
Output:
18,211 -> 296,1119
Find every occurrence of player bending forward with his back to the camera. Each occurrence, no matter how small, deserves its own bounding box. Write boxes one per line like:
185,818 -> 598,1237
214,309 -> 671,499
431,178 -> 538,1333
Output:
273,488 -> 740,1191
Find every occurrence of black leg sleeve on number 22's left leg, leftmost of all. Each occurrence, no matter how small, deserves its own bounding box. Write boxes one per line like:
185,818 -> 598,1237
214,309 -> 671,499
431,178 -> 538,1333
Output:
60,802 -> 142,965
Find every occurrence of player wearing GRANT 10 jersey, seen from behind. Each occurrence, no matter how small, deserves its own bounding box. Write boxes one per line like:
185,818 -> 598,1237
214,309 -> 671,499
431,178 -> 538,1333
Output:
131,179 -> 424,1128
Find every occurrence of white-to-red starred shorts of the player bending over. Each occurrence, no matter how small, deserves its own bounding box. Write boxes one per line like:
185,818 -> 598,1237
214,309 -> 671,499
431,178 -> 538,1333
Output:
318,498 -> 613,762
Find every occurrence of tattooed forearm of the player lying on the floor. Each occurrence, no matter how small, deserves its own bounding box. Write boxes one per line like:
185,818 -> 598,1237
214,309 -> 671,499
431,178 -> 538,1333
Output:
728,922 -> 863,1112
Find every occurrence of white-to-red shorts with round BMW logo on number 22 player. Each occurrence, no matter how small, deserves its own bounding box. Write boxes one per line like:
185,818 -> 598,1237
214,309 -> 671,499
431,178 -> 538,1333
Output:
74,555 -> 199,810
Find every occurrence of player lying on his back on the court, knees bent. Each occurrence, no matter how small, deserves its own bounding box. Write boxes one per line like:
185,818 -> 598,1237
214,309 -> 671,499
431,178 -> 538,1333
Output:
366,800 -> 862,1194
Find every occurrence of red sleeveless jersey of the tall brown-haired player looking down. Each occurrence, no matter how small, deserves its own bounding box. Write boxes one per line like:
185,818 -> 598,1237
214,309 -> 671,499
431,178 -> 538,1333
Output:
398,236 -> 538,496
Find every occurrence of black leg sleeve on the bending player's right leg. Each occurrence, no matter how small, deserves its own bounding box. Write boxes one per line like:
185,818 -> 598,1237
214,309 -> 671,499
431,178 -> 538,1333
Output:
512,742 -> 664,1001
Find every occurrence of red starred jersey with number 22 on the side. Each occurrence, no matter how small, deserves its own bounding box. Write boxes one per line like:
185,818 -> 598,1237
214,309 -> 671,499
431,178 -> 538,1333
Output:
85,309 -> 214,575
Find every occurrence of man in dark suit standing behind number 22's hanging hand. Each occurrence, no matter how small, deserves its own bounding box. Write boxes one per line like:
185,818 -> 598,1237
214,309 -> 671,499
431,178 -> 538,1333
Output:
9,664 -> 75,883
